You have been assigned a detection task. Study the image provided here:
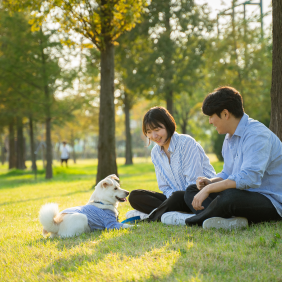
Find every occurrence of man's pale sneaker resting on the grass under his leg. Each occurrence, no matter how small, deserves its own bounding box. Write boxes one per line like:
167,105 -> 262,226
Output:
203,217 -> 248,230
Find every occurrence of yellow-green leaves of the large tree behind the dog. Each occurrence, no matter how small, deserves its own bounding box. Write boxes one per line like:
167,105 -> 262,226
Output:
3,0 -> 147,50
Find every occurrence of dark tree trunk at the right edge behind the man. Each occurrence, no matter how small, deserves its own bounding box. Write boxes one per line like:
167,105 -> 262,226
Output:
269,0 -> 282,141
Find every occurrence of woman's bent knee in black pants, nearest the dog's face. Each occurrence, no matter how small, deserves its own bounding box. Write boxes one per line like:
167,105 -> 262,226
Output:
128,189 -> 166,214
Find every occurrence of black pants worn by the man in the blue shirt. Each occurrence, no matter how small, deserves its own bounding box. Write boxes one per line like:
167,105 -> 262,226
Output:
184,185 -> 282,225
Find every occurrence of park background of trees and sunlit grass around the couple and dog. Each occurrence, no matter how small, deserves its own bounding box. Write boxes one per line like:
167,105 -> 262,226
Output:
0,0 -> 282,281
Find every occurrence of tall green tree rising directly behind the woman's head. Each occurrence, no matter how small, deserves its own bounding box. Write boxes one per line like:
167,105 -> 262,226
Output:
137,0 -> 212,113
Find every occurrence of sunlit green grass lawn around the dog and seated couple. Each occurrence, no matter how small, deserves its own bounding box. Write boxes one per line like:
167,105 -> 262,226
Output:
0,159 -> 282,282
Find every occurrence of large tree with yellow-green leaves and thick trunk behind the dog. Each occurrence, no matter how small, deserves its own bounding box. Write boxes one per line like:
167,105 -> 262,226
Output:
5,0 -> 146,182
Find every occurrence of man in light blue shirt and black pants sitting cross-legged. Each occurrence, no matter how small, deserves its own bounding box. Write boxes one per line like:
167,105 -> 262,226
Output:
184,86 -> 282,229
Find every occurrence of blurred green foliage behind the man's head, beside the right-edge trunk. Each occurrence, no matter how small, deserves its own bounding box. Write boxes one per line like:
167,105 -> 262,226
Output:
204,19 -> 272,126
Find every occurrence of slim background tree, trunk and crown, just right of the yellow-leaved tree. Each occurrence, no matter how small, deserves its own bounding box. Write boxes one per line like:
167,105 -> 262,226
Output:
115,28 -> 151,165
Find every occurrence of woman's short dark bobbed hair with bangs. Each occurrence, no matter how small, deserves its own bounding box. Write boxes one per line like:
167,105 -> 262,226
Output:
142,107 -> 176,140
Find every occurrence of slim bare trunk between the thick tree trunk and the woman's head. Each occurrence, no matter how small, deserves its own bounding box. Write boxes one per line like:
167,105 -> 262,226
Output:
124,93 -> 133,165
